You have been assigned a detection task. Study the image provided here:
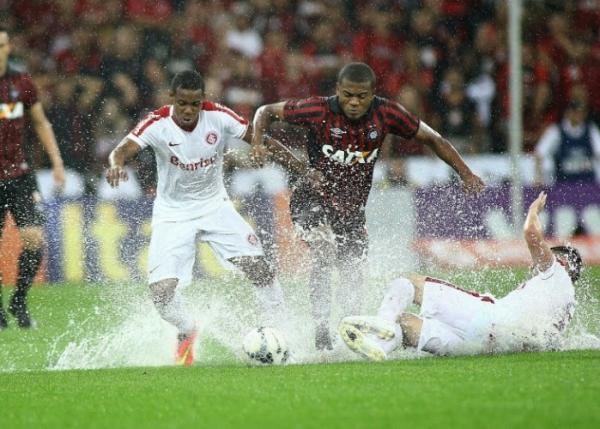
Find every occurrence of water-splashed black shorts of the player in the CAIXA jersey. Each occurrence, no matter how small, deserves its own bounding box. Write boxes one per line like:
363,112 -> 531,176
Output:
290,188 -> 369,260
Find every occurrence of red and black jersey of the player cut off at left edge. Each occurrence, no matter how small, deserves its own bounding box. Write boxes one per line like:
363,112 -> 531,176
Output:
0,68 -> 38,180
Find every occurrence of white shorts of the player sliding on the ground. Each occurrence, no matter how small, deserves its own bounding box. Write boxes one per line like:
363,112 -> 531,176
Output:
417,277 -> 496,355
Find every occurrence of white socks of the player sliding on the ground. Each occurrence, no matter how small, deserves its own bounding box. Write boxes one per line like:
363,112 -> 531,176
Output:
375,277 -> 415,353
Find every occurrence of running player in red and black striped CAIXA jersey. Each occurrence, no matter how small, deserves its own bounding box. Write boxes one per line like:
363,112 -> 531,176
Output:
252,63 -> 484,350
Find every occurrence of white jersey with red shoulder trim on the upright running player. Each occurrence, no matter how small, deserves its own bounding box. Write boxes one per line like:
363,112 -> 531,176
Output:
126,102 -> 248,221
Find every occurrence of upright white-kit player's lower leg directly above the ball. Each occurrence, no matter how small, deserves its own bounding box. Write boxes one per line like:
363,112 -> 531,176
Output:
229,256 -> 288,326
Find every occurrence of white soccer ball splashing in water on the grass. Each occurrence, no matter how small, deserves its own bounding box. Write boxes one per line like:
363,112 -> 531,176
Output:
243,326 -> 289,365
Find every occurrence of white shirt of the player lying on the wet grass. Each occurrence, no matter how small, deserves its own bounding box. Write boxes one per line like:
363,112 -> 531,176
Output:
494,260 -> 576,351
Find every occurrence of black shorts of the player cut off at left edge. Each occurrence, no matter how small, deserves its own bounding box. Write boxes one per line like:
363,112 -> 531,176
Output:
0,174 -> 45,231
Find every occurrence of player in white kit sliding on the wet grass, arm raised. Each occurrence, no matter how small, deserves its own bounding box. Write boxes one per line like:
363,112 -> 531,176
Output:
340,192 -> 582,361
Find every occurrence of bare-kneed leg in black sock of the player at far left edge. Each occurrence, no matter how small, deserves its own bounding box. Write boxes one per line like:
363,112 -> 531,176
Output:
8,226 -> 45,328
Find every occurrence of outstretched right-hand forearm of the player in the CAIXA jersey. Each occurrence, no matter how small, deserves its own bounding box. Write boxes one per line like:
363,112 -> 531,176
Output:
416,121 -> 485,193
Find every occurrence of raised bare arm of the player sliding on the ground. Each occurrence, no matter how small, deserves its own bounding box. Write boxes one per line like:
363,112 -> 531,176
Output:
523,192 -> 554,271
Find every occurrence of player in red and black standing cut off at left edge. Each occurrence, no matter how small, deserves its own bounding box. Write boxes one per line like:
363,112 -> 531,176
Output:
0,27 -> 65,328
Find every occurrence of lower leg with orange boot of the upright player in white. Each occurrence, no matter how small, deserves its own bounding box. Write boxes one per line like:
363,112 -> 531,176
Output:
150,278 -> 196,366
